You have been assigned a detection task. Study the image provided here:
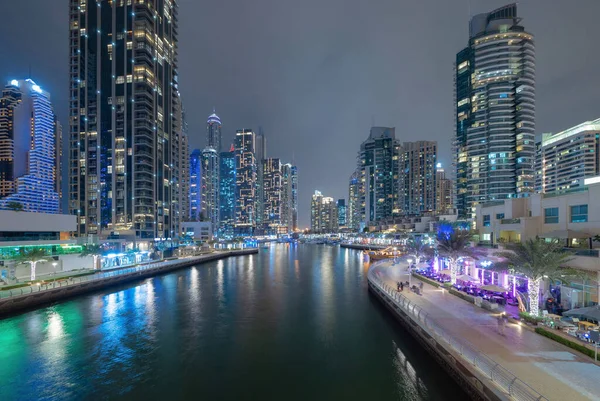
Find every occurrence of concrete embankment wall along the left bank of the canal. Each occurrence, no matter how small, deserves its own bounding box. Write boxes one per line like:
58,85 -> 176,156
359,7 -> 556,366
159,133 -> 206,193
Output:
0,249 -> 258,317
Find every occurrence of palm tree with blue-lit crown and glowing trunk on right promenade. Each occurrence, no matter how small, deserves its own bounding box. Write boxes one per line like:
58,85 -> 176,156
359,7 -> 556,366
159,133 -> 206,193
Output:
436,223 -> 478,284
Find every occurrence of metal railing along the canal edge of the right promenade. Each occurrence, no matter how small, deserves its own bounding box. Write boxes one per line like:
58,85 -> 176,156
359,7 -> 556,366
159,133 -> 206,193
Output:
367,261 -> 548,401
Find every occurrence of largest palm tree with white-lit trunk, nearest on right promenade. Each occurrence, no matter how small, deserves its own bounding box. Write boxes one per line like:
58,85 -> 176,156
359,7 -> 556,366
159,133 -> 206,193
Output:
494,238 -> 577,316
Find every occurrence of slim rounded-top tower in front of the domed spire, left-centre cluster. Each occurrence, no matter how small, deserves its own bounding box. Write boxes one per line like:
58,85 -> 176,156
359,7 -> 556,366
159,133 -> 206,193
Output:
200,148 -> 219,231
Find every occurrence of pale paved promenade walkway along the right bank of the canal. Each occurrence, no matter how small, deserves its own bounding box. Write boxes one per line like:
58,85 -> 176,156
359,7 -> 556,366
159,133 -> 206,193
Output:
379,261 -> 600,401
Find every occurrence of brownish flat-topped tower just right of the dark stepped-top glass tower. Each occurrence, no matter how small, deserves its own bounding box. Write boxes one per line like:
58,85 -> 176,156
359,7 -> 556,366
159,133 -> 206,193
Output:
400,141 -> 437,215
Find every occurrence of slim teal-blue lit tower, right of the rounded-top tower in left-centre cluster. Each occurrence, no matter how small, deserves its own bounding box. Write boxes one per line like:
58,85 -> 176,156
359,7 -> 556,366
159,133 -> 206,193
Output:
219,146 -> 236,237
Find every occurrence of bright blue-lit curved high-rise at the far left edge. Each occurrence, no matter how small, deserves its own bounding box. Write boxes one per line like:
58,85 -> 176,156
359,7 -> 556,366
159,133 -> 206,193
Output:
0,79 -> 61,213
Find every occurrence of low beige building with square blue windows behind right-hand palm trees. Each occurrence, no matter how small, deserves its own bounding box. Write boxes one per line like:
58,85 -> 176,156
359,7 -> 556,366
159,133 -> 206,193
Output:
476,176 -> 600,309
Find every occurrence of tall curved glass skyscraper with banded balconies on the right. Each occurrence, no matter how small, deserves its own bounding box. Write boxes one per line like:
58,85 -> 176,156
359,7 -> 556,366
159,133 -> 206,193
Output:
454,4 -> 535,217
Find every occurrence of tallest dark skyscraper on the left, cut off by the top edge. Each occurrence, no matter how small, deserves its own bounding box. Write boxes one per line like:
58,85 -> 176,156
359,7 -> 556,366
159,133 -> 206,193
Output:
69,0 -> 183,244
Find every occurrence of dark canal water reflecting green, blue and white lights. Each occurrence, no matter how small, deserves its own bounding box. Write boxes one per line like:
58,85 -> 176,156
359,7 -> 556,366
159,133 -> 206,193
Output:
0,244 -> 466,401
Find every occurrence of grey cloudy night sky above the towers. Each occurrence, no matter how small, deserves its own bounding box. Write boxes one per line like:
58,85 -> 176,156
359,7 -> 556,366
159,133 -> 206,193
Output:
0,0 -> 600,227
